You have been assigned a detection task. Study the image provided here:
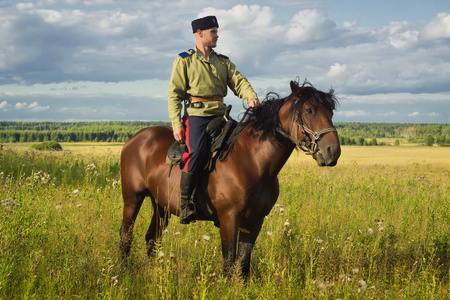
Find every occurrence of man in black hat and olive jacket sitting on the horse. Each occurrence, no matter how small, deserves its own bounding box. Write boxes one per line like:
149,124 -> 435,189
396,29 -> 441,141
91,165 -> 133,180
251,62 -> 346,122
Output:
168,16 -> 259,224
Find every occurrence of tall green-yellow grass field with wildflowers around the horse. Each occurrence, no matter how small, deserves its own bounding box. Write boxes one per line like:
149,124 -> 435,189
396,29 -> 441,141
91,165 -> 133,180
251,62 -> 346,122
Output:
0,143 -> 450,299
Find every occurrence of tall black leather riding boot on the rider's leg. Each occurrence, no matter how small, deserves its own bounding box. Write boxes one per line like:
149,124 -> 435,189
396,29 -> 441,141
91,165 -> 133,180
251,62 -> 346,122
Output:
180,172 -> 197,224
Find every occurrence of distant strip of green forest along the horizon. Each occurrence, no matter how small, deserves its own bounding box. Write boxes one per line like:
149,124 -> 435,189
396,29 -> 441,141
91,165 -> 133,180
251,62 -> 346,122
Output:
0,121 -> 450,146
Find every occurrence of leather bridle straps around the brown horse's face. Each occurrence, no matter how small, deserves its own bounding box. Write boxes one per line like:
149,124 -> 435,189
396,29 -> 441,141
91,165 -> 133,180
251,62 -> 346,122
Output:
276,102 -> 337,155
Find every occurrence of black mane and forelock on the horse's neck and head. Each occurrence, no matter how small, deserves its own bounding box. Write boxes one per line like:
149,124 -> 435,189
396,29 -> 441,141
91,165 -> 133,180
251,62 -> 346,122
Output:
237,81 -> 338,142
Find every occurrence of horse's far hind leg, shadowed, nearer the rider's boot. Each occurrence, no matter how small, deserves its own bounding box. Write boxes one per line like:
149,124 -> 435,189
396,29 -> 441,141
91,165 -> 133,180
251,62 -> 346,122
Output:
145,199 -> 170,256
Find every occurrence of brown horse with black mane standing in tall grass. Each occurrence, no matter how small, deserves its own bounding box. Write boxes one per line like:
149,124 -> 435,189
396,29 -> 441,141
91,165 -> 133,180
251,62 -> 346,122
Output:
120,82 -> 341,275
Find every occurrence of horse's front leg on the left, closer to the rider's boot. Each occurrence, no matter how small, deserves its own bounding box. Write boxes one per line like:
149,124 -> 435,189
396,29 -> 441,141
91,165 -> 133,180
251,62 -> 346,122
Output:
219,216 -> 238,276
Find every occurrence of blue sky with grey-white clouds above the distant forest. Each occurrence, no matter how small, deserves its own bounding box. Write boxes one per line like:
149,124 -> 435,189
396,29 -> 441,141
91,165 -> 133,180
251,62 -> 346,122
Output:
0,0 -> 450,123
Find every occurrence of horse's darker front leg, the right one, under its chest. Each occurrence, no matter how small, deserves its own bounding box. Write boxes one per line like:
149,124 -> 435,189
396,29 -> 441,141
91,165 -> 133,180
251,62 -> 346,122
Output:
237,217 -> 264,277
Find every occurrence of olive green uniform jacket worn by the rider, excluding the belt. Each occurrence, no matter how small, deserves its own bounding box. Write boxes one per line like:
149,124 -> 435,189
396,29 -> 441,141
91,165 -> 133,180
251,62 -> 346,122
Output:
168,48 -> 257,129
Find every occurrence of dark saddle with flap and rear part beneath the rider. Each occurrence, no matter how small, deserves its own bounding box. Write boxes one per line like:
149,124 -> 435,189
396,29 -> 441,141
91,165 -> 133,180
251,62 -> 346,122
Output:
166,105 -> 238,227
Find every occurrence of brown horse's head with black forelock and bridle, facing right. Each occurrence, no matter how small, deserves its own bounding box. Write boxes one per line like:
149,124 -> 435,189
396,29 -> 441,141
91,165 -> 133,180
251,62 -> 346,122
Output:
280,81 -> 341,166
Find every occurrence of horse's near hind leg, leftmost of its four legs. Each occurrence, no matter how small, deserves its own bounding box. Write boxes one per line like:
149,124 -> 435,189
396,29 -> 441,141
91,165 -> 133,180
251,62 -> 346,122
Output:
120,192 -> 145,259
